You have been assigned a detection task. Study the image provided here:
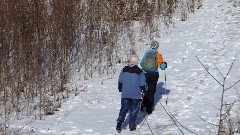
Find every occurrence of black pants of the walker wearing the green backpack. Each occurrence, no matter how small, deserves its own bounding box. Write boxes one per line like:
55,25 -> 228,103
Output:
143,72 -> 159,113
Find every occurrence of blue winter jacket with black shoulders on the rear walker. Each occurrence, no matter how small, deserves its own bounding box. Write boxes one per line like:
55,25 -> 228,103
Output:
118,65 -> 147,99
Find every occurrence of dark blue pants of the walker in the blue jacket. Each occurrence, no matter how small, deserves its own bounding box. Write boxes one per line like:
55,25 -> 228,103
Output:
117,98 -> 141,129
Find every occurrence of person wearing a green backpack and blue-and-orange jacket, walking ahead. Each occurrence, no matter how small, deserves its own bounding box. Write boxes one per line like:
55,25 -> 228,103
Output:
140,40 -> 167,114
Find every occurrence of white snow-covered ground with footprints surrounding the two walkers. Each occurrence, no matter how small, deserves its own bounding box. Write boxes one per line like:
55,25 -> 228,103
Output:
9,0 -> 240,135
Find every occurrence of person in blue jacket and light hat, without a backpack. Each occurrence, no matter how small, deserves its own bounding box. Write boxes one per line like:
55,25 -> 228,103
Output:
116,55 -> 147,132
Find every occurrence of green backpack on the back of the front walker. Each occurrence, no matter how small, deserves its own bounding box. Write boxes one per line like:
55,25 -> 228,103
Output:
141,52 -> 157,73
